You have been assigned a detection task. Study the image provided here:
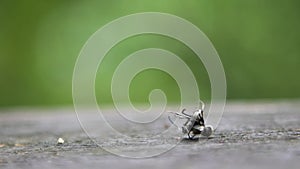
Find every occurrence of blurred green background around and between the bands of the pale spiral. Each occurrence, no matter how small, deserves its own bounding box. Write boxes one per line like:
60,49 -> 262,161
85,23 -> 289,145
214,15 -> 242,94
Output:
0,0 -> 300,107
